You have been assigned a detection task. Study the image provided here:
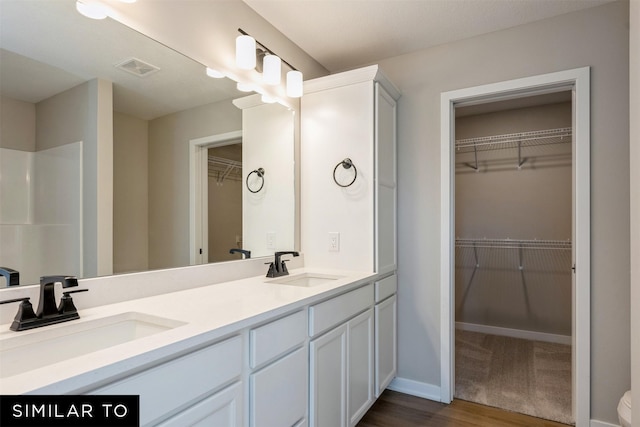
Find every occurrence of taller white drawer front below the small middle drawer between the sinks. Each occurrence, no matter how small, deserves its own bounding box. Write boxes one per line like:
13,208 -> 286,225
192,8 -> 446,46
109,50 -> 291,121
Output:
249,348 -> 309,427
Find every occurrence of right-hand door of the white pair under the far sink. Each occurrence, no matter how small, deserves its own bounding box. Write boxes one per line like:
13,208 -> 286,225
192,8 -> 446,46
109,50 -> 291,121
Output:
347,309 -> 374,426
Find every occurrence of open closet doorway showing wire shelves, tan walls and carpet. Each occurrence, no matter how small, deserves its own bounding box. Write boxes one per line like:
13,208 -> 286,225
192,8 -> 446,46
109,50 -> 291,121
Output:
454,91 -> 573,424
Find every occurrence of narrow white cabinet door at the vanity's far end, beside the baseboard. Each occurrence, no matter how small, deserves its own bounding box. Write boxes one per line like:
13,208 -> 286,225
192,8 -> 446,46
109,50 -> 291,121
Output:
375,295 -> 397,397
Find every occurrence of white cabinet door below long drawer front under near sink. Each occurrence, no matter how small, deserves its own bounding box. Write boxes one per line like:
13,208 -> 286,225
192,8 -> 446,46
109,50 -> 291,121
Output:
158,382 -> 243,427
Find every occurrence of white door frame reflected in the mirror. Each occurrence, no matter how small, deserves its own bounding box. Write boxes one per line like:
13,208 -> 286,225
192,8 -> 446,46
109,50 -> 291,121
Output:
189,130 -> 242,265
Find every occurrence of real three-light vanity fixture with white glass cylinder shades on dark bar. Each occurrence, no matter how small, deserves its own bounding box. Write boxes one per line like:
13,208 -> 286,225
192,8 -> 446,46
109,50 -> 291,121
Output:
236,28 -> 303,98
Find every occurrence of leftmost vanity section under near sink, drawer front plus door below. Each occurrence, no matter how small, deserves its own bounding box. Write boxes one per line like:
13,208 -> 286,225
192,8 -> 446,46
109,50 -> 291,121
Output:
92,335 -> 244,427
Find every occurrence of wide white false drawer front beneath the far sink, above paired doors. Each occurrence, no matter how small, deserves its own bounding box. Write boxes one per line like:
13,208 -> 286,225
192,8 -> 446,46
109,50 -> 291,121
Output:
309,284 -> 373,336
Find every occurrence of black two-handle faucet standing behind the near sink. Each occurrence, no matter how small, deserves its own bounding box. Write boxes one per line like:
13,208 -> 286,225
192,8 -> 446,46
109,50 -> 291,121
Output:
0,276 -> 89,331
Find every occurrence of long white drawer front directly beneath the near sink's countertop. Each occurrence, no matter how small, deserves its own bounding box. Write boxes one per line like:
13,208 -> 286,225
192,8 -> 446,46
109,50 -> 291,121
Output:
94,336 -> 242,426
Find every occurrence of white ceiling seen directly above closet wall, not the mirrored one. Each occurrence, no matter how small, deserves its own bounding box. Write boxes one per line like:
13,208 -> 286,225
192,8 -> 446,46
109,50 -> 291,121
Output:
243,0 -> 614,73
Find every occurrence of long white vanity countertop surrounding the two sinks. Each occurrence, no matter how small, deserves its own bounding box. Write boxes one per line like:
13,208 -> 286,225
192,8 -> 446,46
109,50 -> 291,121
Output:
0,268 -> 376,394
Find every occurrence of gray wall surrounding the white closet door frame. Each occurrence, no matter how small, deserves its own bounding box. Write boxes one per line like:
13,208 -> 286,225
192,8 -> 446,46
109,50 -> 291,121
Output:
380,2 -> 630,422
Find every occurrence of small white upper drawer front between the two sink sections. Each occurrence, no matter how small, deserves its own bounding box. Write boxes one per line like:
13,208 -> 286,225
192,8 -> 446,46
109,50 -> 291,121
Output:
249,310 -> 307,369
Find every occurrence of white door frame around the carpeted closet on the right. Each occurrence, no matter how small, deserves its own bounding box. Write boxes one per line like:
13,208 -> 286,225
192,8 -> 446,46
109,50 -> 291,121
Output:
440,67 -> 591,426
